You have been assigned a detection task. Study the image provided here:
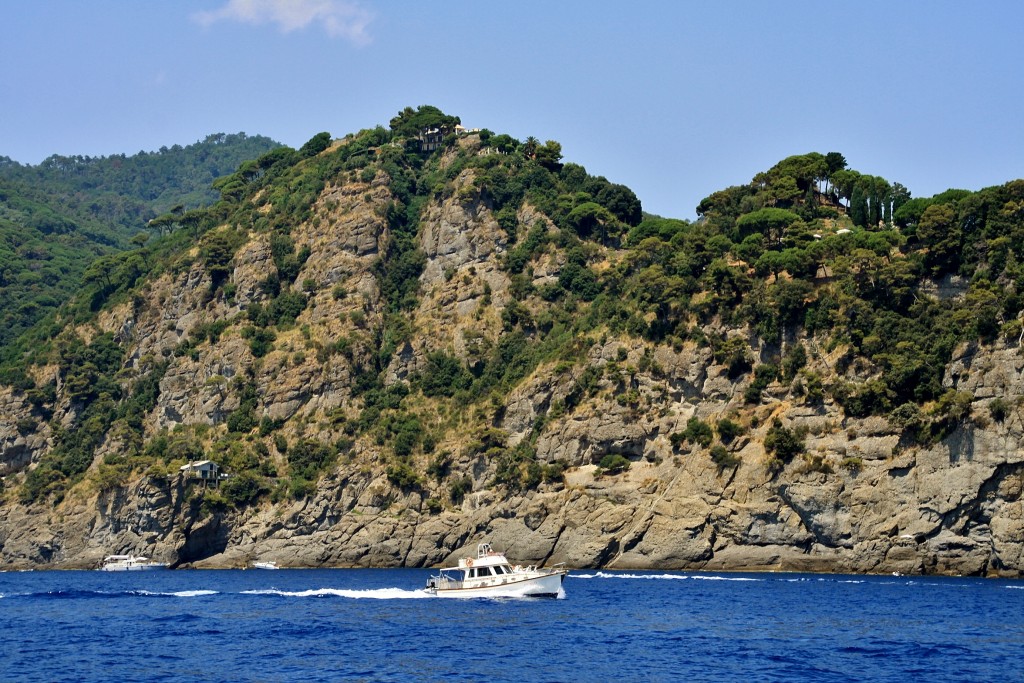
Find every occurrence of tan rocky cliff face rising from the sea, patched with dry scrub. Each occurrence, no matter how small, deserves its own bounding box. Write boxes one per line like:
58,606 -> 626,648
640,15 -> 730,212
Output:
0,125 -> 1024,575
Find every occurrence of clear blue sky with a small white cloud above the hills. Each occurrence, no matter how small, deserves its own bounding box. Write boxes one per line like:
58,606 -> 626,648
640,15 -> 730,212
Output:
0,0 -> 1024,218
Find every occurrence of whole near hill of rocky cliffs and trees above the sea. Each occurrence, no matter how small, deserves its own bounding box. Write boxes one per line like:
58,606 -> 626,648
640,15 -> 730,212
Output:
0,108 -> 1024,575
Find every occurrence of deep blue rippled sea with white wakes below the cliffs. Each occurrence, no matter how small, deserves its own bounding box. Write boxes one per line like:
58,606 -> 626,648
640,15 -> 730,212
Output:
0,569 -> 1024,683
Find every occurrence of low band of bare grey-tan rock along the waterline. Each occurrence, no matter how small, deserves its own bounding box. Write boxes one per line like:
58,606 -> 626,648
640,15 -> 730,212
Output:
0,378 -> 1024,575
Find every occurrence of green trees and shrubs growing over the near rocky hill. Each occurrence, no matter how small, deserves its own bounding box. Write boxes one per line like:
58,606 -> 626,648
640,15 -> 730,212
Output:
0,106 -> 1024,506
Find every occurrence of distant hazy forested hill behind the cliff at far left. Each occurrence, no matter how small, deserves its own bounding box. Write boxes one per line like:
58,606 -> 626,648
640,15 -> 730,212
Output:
0,133 -> 279,347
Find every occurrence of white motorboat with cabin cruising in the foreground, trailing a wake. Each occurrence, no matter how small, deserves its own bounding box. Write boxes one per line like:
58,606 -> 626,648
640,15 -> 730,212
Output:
423,543 -> 568,598
